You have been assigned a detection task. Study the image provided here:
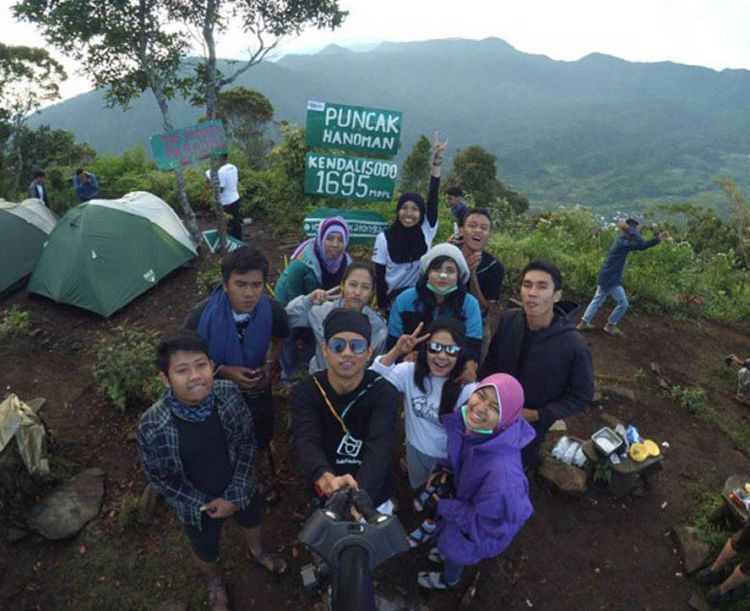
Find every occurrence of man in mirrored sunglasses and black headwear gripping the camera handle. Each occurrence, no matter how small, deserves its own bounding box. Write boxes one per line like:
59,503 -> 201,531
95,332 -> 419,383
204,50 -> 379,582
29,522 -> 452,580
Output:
289,309 -> 398,514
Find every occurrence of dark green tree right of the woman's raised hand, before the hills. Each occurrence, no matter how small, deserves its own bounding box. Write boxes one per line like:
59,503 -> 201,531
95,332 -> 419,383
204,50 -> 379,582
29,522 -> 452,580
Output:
447,144 -> 529,214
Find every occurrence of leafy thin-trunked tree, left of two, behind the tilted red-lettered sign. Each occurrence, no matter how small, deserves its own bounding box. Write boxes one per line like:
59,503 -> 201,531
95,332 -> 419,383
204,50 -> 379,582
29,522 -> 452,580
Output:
14,0 -> 201,243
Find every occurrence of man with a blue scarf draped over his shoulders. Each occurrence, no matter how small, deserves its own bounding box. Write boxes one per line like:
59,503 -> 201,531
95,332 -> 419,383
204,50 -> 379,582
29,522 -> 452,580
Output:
184,246 -> 289,503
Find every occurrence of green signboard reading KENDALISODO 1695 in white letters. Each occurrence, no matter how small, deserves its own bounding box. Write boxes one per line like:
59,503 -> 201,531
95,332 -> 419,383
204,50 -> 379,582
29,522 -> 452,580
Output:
305,153 -> 398,202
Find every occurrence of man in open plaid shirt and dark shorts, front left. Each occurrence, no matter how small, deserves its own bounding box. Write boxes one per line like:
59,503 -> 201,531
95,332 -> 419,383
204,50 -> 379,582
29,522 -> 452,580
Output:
138,330 -> 286,610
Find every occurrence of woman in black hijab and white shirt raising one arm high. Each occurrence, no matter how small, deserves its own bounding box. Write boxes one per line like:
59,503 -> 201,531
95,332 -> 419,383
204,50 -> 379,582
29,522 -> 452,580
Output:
372,133 -> 448,312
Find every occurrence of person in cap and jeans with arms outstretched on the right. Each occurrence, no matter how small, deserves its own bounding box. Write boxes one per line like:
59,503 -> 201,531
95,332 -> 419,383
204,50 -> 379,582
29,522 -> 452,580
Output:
577,219 -> 668,336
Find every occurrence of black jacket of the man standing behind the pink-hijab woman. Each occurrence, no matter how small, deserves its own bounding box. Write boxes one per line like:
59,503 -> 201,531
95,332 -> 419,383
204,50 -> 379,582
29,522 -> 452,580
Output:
480,302 -> 594,441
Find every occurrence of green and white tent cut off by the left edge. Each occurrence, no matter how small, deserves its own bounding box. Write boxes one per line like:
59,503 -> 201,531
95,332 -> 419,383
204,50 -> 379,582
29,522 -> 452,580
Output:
0,199 -> 57,293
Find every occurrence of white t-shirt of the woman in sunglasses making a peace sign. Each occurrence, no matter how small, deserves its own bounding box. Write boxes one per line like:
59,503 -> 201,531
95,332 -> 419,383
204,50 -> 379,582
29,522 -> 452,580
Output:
370,356 -> 477,458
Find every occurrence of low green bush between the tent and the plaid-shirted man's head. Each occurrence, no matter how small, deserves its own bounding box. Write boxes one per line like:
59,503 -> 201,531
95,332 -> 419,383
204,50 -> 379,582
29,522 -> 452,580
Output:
92,324 -> 162,410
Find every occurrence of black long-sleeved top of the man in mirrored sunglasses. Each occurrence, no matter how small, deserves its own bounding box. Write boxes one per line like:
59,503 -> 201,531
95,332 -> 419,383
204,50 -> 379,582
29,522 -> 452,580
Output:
289,369 -> 399,507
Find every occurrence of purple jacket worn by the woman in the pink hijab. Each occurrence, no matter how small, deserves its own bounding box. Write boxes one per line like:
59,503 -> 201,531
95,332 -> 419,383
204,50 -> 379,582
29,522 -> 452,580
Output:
437,410 -> 535,565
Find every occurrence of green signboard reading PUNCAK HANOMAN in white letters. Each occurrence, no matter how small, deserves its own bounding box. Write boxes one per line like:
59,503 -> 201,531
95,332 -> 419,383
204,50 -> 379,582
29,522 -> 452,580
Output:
305,101 -> 401,157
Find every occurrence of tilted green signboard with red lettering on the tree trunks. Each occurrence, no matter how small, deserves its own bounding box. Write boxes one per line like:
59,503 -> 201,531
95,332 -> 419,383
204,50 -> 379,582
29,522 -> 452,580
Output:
151,120 -> 227,170
